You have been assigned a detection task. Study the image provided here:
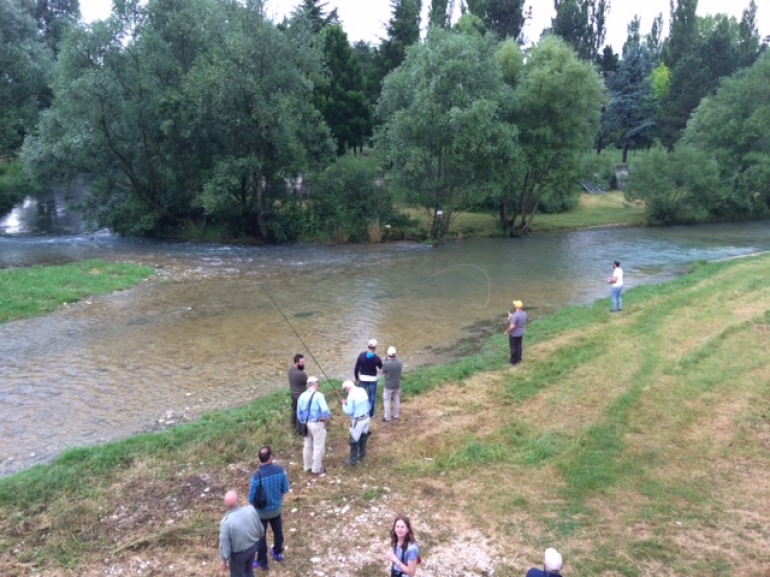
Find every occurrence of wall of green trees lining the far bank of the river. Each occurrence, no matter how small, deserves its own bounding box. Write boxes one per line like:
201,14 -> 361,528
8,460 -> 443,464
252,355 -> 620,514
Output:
0,0 -> 770,242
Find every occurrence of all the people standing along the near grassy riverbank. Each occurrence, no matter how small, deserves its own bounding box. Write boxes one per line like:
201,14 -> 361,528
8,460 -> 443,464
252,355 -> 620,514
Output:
214,318 -> 576,577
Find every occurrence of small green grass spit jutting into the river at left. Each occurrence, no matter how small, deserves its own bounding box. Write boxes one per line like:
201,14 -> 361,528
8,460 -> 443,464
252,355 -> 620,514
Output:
0,260 -> 153,323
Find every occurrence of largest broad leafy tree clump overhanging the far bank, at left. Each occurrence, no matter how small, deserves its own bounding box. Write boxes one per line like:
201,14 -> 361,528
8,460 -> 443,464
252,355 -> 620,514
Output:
24,0 -> 331,240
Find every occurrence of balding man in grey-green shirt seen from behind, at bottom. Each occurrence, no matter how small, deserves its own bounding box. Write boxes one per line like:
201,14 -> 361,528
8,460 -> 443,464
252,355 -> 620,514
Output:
219,491 -> 265,577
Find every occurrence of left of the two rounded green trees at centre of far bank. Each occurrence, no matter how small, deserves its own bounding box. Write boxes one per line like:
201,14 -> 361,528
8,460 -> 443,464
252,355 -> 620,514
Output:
377,28 -> 516,240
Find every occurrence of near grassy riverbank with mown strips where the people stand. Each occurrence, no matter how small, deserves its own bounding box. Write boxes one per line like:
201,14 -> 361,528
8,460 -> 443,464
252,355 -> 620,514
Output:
0,255 -> 770,577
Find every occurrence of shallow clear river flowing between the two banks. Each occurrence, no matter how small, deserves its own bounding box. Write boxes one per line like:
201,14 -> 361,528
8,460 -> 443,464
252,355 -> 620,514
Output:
0,191 -> 770,475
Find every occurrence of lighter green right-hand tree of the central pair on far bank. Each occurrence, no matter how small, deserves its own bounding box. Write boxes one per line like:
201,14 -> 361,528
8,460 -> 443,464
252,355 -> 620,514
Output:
500,36 -> 605,236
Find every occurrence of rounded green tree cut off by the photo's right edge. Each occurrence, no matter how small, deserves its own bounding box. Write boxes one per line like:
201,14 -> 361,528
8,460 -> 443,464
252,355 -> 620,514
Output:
683,53 -> 770,218
